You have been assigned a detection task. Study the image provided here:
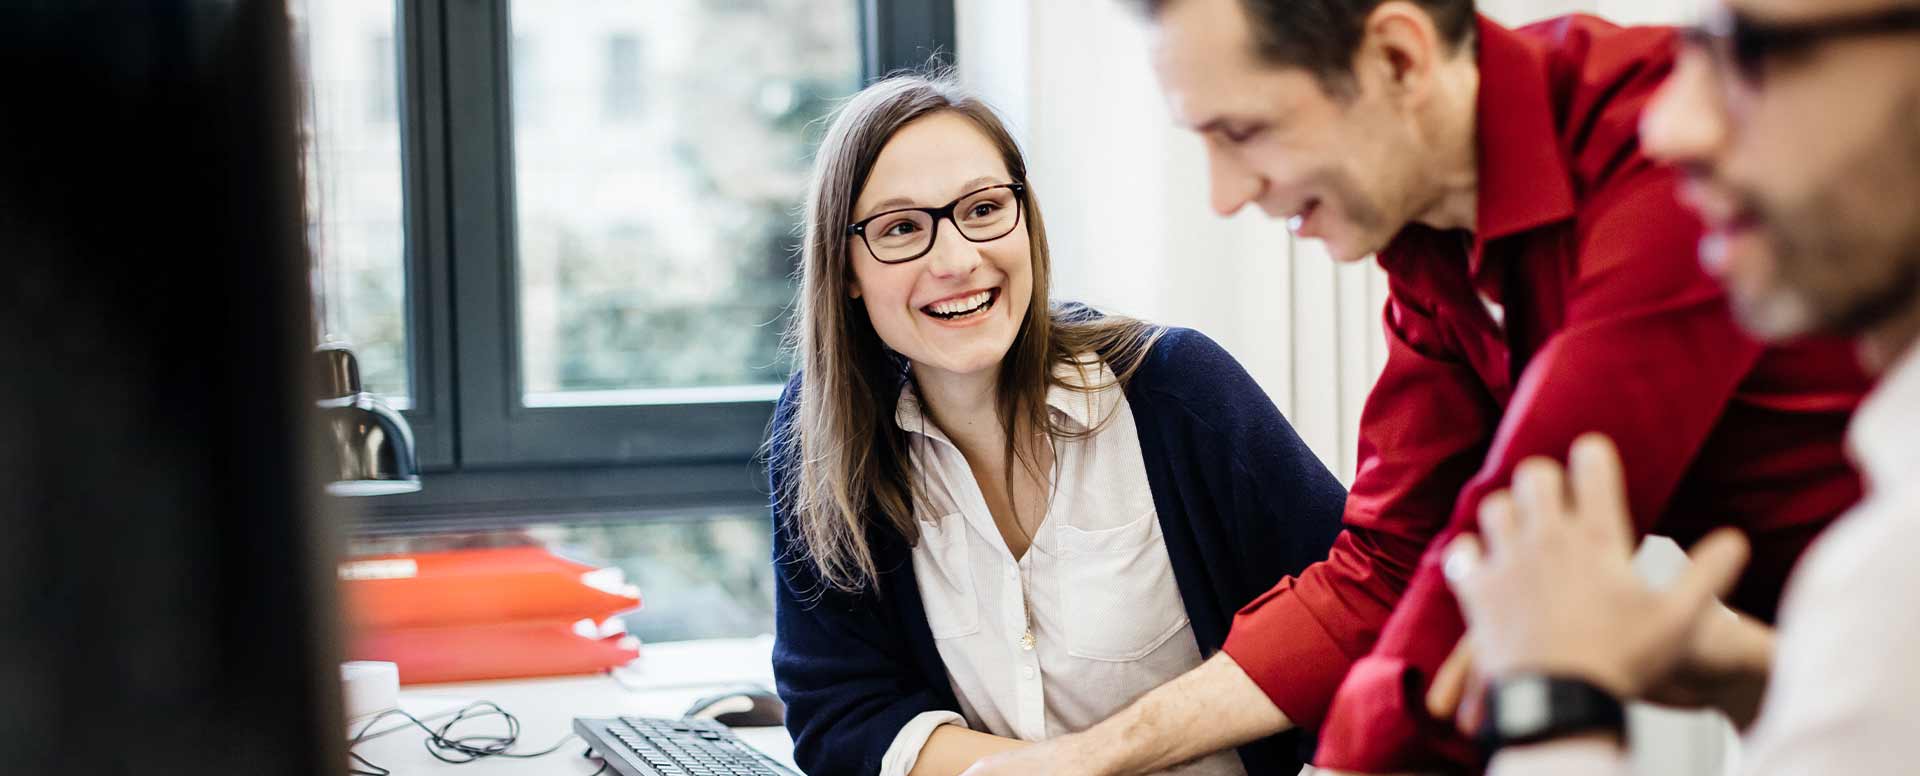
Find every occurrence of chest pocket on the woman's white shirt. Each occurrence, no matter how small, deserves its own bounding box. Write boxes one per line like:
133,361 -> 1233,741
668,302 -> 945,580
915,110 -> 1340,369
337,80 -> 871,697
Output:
1058,511 -> 1187,663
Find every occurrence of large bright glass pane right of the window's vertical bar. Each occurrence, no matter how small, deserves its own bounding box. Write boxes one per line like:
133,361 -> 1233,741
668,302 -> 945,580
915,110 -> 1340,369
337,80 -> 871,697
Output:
507,0 -> 860,407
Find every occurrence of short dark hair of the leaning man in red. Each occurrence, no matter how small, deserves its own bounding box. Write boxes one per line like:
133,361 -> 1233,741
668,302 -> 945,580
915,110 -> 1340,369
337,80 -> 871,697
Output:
1129,0 -> 1475,90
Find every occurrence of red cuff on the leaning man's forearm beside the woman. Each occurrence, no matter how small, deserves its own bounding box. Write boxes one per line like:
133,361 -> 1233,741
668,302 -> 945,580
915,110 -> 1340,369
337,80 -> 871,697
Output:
1221,578 -> 1352,728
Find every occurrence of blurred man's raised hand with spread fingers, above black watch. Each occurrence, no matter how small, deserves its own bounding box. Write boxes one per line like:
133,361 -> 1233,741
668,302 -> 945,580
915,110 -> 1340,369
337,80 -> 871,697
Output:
1446,434 -> 1747,699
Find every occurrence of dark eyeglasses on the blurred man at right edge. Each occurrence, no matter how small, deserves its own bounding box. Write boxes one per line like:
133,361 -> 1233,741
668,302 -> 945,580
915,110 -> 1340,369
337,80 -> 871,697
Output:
1680,6 -> 1920,88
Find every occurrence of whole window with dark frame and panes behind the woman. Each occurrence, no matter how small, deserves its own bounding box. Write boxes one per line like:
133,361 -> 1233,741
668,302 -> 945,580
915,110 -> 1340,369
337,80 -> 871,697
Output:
290,0 -> 954,533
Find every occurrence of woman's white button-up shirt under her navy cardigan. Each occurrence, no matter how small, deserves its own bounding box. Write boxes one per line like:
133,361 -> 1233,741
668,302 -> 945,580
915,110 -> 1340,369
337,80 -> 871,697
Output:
879,359 -> 1246,776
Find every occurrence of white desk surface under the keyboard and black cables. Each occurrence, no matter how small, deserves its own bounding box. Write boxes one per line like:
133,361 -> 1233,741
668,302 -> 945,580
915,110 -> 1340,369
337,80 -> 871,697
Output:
349,638 -> 799,776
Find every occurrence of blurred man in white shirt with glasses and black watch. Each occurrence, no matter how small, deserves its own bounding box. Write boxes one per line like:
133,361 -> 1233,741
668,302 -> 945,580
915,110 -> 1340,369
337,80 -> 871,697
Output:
1446,0 -> 1920,776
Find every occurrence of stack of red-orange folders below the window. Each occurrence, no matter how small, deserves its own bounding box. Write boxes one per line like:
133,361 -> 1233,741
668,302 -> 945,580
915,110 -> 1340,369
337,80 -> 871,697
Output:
340,547 -> 639,684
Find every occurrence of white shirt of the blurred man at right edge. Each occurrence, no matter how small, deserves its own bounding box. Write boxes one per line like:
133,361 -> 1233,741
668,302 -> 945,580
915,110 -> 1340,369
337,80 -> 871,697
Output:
1492,346 -> 1920,776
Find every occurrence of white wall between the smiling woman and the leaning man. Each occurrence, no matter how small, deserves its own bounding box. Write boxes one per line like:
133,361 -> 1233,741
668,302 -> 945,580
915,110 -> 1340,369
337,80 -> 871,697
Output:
956,0 -> 1730,776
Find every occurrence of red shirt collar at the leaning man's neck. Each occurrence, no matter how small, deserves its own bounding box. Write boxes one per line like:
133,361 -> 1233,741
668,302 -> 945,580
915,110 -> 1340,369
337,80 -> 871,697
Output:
1469,15 -> 1574,275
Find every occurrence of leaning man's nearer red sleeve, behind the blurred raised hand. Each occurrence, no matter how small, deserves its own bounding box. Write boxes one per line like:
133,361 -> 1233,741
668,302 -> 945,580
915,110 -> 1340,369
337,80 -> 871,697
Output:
1319,167 -> 1761,772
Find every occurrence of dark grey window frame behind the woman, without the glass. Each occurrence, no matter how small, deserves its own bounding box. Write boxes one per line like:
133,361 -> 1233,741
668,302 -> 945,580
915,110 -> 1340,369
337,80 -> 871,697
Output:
355,0 -> 954,534
